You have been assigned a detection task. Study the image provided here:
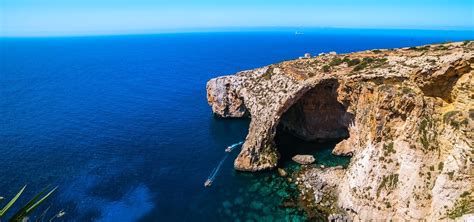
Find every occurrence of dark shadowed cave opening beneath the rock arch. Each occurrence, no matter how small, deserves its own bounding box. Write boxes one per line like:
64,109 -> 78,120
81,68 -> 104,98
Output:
275,79 -> 353,166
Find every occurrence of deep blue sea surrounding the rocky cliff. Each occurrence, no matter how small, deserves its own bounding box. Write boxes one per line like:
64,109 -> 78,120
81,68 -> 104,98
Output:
0,29 -> 474,221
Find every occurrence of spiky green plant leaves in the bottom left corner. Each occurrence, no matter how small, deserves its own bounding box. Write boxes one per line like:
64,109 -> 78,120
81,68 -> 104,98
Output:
0,185 -> 58,222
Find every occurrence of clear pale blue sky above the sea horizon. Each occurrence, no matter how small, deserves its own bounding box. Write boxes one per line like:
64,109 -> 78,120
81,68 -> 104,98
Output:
0,0 -> 474,36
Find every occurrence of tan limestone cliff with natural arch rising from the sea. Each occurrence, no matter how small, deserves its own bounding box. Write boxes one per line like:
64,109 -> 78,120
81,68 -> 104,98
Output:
207,41 -> 474,220
